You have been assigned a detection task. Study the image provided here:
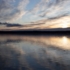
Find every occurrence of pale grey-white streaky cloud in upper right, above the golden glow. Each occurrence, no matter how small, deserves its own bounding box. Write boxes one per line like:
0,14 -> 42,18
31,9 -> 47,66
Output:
31,0 -> 70,18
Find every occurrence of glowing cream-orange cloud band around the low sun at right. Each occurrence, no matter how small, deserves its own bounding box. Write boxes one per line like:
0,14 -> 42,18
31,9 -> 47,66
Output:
21,15 -> 70,30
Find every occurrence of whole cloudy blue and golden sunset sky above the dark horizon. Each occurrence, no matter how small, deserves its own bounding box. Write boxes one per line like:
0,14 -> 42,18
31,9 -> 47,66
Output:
0,0 -> 70,27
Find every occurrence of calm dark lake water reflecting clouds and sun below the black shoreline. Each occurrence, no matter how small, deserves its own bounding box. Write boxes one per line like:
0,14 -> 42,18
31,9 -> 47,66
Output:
0,35 -> 70,70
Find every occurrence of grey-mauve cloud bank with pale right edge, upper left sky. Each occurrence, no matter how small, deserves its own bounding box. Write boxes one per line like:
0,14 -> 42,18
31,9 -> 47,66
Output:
0,0 -> 29,22
